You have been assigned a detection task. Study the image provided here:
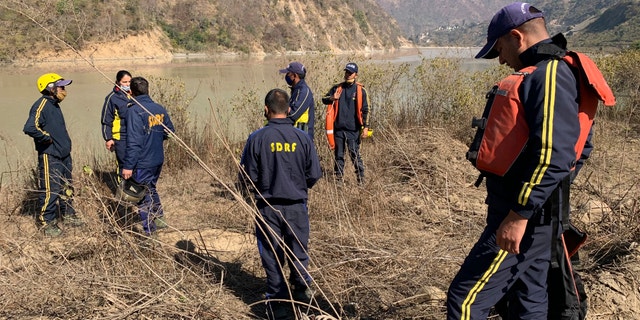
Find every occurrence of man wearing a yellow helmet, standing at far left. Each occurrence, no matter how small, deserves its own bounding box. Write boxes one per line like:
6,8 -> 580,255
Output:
23,73 -> 84,237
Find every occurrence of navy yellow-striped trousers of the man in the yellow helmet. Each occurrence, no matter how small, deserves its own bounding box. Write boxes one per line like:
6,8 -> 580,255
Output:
36,153 -> 75,226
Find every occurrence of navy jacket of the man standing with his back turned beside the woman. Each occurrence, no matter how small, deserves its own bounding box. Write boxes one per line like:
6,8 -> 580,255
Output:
123,95 -> 174,170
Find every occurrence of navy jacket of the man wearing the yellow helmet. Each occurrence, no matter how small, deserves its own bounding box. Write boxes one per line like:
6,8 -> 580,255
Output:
23,96 -> 71,158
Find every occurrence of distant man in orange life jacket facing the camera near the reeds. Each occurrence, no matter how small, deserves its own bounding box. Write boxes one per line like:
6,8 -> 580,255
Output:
322,62 -> 369,185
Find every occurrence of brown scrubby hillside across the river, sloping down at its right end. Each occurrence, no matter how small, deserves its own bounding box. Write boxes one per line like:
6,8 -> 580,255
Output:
0,0 -> 402,62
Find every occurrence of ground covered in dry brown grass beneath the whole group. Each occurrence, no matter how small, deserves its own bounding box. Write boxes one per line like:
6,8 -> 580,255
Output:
0,122 -> 640,319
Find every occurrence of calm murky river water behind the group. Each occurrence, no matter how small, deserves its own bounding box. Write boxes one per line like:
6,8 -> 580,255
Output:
0,48 -> 487,184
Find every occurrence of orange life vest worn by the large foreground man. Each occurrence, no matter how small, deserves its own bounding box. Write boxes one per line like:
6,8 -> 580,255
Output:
467,51 -> 616,176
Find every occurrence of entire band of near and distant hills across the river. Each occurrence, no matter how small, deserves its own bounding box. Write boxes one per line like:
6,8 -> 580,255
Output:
0,0 -> 640,63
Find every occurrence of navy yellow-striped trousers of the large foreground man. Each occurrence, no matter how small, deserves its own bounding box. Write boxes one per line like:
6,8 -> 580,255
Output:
447,207 -> 552,320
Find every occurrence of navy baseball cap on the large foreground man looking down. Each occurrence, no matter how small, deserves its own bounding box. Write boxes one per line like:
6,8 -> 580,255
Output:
476,2 -> 544,59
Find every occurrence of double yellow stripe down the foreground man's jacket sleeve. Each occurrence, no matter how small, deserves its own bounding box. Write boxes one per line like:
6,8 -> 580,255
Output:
518,60 -> 558,206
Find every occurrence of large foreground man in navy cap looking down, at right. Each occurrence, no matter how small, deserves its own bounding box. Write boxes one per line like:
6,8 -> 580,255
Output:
447,2 -> 580,320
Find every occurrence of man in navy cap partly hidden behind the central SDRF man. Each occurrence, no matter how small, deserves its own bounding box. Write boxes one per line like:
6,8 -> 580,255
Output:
280,61 -> 315,141
